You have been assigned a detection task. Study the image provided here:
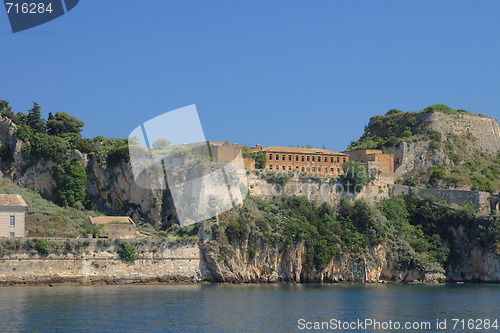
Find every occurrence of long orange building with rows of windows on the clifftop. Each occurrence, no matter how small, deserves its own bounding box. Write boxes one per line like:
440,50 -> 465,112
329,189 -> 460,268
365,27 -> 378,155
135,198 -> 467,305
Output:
261,146 -> 349,176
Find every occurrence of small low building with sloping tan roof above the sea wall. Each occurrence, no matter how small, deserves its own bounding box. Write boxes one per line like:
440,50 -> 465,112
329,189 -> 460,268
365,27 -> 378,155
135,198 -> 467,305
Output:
83,216 -> 138,238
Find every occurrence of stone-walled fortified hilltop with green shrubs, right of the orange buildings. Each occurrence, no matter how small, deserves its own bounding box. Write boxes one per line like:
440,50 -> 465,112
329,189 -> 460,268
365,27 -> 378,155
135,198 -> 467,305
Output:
349,105 -> 500,192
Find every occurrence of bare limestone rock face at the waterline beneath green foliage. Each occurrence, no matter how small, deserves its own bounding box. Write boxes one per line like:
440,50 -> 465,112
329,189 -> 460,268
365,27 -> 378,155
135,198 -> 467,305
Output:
200,232 -> 446,283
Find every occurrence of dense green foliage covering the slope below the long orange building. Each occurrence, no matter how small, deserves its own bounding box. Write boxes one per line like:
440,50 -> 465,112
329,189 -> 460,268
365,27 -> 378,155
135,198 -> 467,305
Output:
212,195 -> 474,271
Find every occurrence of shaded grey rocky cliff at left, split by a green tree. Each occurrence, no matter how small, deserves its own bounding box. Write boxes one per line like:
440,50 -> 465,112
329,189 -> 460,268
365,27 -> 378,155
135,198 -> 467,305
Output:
0,117 -> 175,228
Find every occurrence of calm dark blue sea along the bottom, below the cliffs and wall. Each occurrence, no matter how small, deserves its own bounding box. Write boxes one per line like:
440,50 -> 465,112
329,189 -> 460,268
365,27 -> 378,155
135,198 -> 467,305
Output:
0,284 -> 500,332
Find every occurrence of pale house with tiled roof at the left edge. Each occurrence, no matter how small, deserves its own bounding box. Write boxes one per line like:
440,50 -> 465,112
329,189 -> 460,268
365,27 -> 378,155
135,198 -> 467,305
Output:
0,194 -> 28,237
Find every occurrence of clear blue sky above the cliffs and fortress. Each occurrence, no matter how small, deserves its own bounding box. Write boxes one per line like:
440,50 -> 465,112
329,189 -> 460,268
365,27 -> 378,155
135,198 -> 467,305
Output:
0,0 -> 500,150
